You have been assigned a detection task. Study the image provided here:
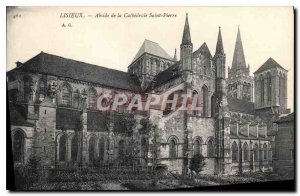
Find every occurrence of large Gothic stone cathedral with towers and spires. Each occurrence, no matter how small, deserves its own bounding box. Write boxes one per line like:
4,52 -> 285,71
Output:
7,15 -> 289,174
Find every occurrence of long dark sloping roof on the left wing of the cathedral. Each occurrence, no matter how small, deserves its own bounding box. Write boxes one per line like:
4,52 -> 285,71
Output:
10,52 -> 141,91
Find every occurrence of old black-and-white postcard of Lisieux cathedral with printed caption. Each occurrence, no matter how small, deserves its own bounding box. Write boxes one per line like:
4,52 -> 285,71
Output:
6,7 -> 295,191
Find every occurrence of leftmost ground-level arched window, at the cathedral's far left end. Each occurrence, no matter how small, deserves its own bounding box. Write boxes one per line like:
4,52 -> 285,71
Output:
13,130 -> 25,162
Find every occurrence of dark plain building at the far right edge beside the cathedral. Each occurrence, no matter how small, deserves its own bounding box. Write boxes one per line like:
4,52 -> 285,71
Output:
274,113 -> 295,177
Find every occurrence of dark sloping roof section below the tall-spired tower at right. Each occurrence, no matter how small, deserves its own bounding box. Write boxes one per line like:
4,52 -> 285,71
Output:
227,96 -> 255,115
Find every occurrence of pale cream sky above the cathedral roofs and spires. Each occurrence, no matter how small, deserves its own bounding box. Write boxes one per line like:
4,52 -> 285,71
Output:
7,7 -> 294,111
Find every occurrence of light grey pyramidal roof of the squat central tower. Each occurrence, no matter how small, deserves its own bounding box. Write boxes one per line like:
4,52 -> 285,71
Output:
132,39 -> 173,62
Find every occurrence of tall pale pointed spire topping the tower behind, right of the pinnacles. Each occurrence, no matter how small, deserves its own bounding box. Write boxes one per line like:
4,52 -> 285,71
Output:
232,27 -> 246,70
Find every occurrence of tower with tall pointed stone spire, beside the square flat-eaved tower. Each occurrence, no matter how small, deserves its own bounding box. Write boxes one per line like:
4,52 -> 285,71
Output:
227,28 -> 253,102
